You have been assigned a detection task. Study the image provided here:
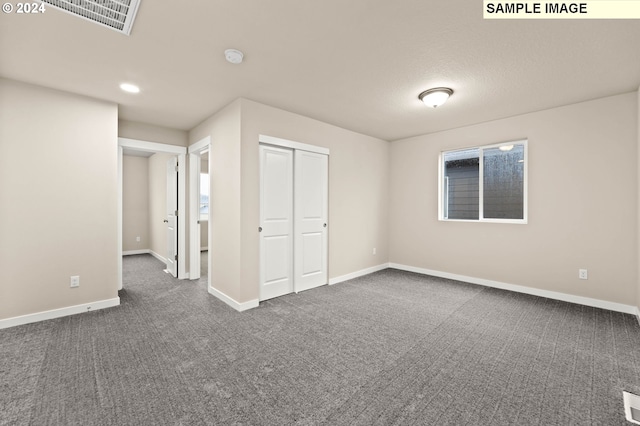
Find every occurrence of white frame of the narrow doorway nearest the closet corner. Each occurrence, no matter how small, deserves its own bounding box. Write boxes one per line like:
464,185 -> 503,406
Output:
187,136 -> 212,282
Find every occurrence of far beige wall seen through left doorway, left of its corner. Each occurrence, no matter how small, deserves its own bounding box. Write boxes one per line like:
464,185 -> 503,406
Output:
122,155 -> 150,252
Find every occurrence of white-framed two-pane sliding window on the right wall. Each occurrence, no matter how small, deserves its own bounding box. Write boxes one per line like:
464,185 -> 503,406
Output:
440,140 -> 527,223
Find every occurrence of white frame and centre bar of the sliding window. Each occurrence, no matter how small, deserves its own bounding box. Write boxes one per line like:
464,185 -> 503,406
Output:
438,139 -> 529,224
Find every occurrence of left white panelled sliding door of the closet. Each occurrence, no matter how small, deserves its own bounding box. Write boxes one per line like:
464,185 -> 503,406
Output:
259,145 -> 293,300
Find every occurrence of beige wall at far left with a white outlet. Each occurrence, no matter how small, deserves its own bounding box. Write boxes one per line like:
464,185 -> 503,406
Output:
0,79 -> 118,319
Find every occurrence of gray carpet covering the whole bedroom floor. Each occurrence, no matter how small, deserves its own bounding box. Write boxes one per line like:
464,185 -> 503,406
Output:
0,255 -> 640,425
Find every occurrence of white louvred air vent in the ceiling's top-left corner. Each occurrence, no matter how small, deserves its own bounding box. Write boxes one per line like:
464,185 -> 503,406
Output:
41,0 -> 140,35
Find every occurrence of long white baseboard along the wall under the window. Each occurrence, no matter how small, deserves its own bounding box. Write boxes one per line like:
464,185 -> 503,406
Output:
389,263 -> 638,315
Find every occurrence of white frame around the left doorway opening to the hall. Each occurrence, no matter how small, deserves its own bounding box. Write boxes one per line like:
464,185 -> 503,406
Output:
117,138 -> 189,290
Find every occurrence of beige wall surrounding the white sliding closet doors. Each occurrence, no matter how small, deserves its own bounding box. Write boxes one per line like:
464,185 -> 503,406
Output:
242,99 -> 389,300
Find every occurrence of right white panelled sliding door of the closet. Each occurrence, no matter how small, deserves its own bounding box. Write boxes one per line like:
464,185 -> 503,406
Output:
294,150 -> 329,292
